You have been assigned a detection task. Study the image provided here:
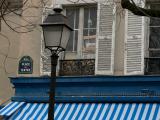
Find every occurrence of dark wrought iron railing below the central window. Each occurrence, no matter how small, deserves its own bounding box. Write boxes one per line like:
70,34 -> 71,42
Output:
59,59 -> 95,76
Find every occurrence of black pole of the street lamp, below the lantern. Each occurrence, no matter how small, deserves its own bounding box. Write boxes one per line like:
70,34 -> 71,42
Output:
48,51 -> 59,120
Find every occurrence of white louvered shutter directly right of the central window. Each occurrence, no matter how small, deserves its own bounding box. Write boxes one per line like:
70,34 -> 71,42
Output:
95,3 -> 115,75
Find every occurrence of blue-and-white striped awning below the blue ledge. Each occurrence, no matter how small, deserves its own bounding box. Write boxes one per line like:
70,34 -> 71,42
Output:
0,102 -> 160,120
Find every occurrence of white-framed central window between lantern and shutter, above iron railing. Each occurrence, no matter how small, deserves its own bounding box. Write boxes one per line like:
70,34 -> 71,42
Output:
66,5 -> 97,58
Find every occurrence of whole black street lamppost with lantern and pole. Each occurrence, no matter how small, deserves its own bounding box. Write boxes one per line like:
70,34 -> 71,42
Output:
41,5 -> 72,120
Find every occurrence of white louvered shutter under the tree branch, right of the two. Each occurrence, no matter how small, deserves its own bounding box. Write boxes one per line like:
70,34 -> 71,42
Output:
124,1 -> 144,75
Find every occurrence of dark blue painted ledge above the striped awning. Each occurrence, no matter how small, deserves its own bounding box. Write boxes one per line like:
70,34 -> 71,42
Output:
10,76 -> 160,102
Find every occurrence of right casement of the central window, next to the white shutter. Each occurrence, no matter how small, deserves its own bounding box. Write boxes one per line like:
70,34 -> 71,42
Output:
83,7 -> 97,58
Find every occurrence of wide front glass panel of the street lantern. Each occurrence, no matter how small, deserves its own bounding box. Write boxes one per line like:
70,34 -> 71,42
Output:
43,25 -> 62,47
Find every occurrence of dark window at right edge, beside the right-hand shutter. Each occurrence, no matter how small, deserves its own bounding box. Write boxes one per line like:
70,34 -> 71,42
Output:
145,4 -> 160,74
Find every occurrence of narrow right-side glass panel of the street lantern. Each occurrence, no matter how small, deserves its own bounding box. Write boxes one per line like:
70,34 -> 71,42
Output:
61,26 -> 71,49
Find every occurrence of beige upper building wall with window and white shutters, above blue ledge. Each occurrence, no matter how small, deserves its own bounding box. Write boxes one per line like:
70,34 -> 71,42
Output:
0,0 -> 159,104
